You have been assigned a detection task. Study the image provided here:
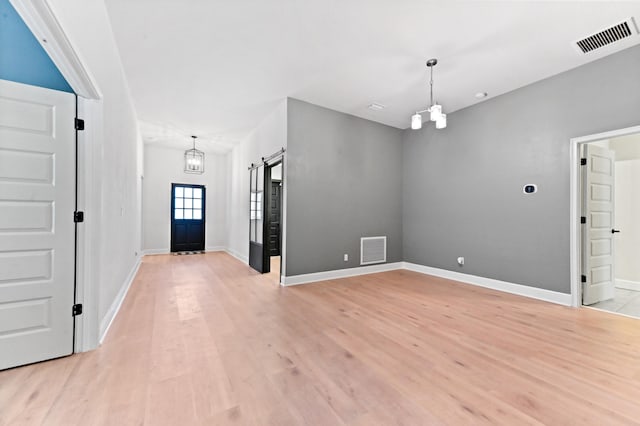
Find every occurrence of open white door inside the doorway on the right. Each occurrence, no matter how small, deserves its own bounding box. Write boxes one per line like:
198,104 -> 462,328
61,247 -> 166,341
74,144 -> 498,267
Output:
582,144 -> 615,305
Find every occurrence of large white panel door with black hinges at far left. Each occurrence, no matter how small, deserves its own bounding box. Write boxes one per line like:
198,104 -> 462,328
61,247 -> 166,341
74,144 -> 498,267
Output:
0,80 -> 75,369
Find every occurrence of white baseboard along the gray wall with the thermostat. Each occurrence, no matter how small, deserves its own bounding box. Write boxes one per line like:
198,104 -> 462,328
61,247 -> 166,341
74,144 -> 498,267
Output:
403,262 -> 571,306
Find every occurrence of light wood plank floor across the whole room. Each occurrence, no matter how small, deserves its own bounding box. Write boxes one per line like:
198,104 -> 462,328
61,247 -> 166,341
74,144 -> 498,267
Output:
0,253 -> 640,426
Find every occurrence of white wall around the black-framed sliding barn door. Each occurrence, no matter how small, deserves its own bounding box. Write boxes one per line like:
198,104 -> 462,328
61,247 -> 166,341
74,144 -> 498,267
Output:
228,99 -> 287,262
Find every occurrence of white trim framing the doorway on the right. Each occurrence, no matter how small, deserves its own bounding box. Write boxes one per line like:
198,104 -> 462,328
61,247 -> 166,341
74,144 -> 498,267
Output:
569,126 -> 640,307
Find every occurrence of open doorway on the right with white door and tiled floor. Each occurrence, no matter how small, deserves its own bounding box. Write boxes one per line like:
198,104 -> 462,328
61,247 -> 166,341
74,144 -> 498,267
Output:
577,128 -> 640,318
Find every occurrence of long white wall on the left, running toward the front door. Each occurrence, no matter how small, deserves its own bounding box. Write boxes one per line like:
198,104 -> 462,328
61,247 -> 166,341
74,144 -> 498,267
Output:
47,0 -> 142,349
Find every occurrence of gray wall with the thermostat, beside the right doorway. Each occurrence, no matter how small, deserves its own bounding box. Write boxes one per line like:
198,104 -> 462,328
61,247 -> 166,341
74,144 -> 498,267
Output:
403,47 -> 640,293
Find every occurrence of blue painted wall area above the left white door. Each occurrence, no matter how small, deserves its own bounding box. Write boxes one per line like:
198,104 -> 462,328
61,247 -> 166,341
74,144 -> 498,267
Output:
0,0 -> 73,93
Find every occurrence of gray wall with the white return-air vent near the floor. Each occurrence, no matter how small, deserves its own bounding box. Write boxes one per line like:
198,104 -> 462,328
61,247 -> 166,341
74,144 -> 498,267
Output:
285,99 -> 402,276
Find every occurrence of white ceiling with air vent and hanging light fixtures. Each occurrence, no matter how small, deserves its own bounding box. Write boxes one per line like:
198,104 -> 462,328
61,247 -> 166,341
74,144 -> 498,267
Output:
105,0 -> 640,152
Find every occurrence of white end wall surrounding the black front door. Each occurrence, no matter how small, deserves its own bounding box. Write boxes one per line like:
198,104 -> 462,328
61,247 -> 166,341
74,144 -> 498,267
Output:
142,144 -> 229,253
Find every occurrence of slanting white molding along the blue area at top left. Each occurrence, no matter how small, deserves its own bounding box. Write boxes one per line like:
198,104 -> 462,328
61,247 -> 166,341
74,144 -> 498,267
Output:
9,0 -> 102,99
